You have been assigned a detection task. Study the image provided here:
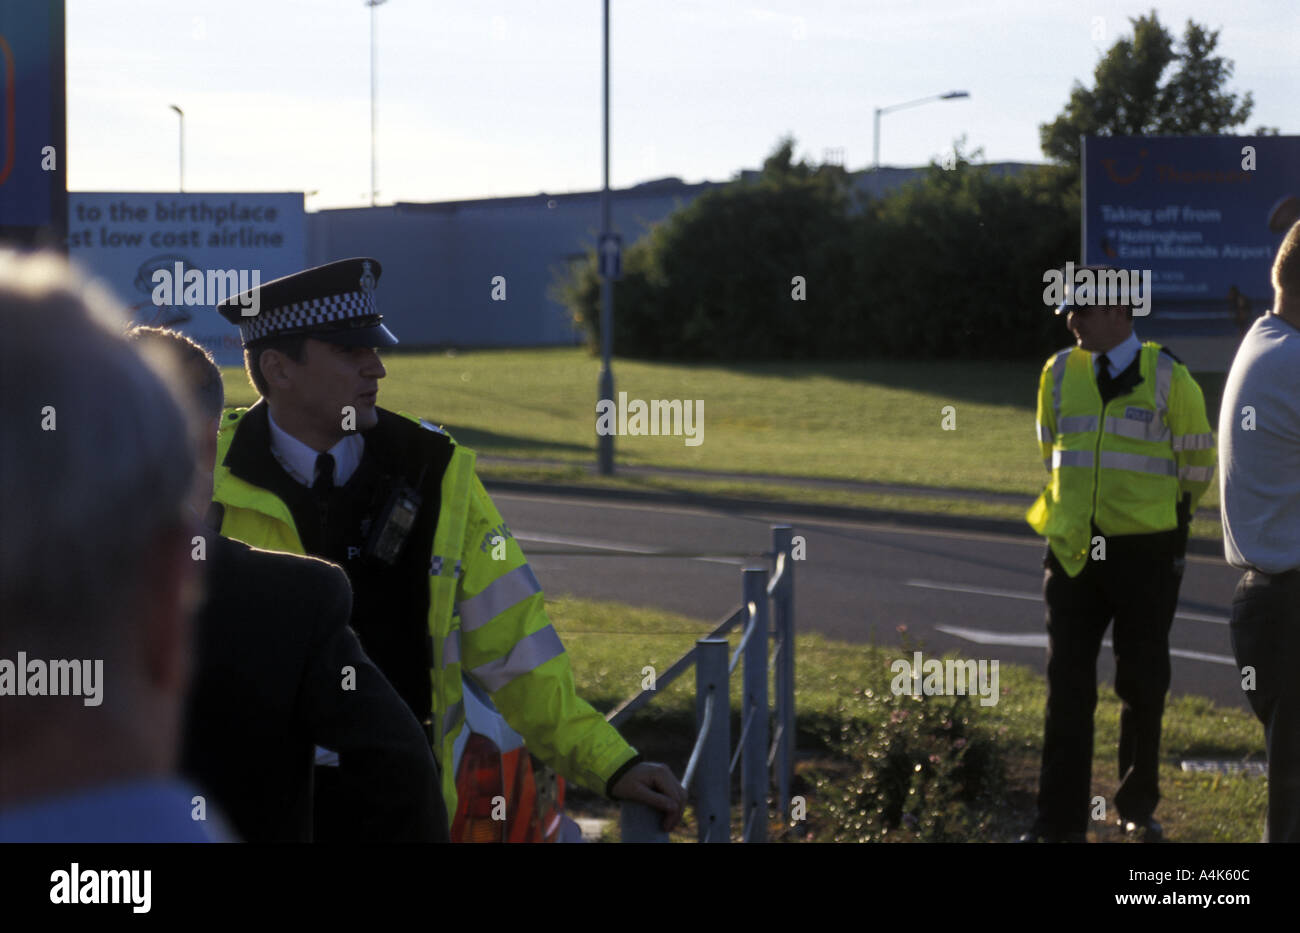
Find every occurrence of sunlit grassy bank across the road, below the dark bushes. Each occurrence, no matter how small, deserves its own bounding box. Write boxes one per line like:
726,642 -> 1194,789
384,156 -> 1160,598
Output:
225,348 -> 1221,524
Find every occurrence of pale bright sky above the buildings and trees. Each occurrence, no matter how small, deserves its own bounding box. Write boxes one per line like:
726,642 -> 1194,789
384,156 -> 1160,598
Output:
66,0 -> 1300,211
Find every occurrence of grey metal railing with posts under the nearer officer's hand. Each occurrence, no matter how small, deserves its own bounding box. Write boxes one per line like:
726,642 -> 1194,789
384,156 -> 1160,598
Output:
607,525 -> 794,842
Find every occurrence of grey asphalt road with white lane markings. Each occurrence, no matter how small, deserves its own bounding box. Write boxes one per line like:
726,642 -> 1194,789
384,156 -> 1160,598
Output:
493,492 -> 1248,709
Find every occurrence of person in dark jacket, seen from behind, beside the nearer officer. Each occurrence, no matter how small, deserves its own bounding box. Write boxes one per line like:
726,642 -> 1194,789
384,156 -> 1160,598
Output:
131,327 -> 447,842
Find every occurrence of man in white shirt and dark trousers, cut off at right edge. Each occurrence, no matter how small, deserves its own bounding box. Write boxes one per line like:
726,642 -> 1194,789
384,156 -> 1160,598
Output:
1218,224 -> 1300,842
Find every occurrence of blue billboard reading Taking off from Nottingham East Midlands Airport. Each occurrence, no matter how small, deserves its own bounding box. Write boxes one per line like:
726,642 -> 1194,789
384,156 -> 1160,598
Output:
1083,136 -> 1300,320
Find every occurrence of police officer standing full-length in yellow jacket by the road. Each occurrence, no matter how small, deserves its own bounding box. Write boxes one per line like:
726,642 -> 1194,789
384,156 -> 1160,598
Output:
1022,266 -> 1214,842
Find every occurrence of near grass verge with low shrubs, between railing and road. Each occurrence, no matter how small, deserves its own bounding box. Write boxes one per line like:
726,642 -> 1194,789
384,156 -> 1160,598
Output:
550,599 -> 1266,842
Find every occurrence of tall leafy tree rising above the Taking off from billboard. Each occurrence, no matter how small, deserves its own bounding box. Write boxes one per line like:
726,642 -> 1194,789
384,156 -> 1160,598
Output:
1039,10 -> 1255,168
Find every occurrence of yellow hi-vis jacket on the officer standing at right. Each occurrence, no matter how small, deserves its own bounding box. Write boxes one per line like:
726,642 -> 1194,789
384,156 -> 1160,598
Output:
1026,342 -> 1214,577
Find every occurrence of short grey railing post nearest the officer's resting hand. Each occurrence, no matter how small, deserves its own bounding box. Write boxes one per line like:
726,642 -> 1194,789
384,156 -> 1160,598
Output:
694,638 -> 731,842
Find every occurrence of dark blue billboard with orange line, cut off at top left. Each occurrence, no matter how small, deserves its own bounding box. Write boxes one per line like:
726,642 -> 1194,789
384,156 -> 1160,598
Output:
0,0 -> 68,246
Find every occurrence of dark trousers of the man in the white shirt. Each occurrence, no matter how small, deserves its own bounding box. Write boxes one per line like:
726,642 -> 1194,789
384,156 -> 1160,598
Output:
1230,570 -> 1300,842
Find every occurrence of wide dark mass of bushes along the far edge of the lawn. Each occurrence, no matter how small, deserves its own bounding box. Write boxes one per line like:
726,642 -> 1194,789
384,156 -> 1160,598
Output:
554,139 -> 1079,360
